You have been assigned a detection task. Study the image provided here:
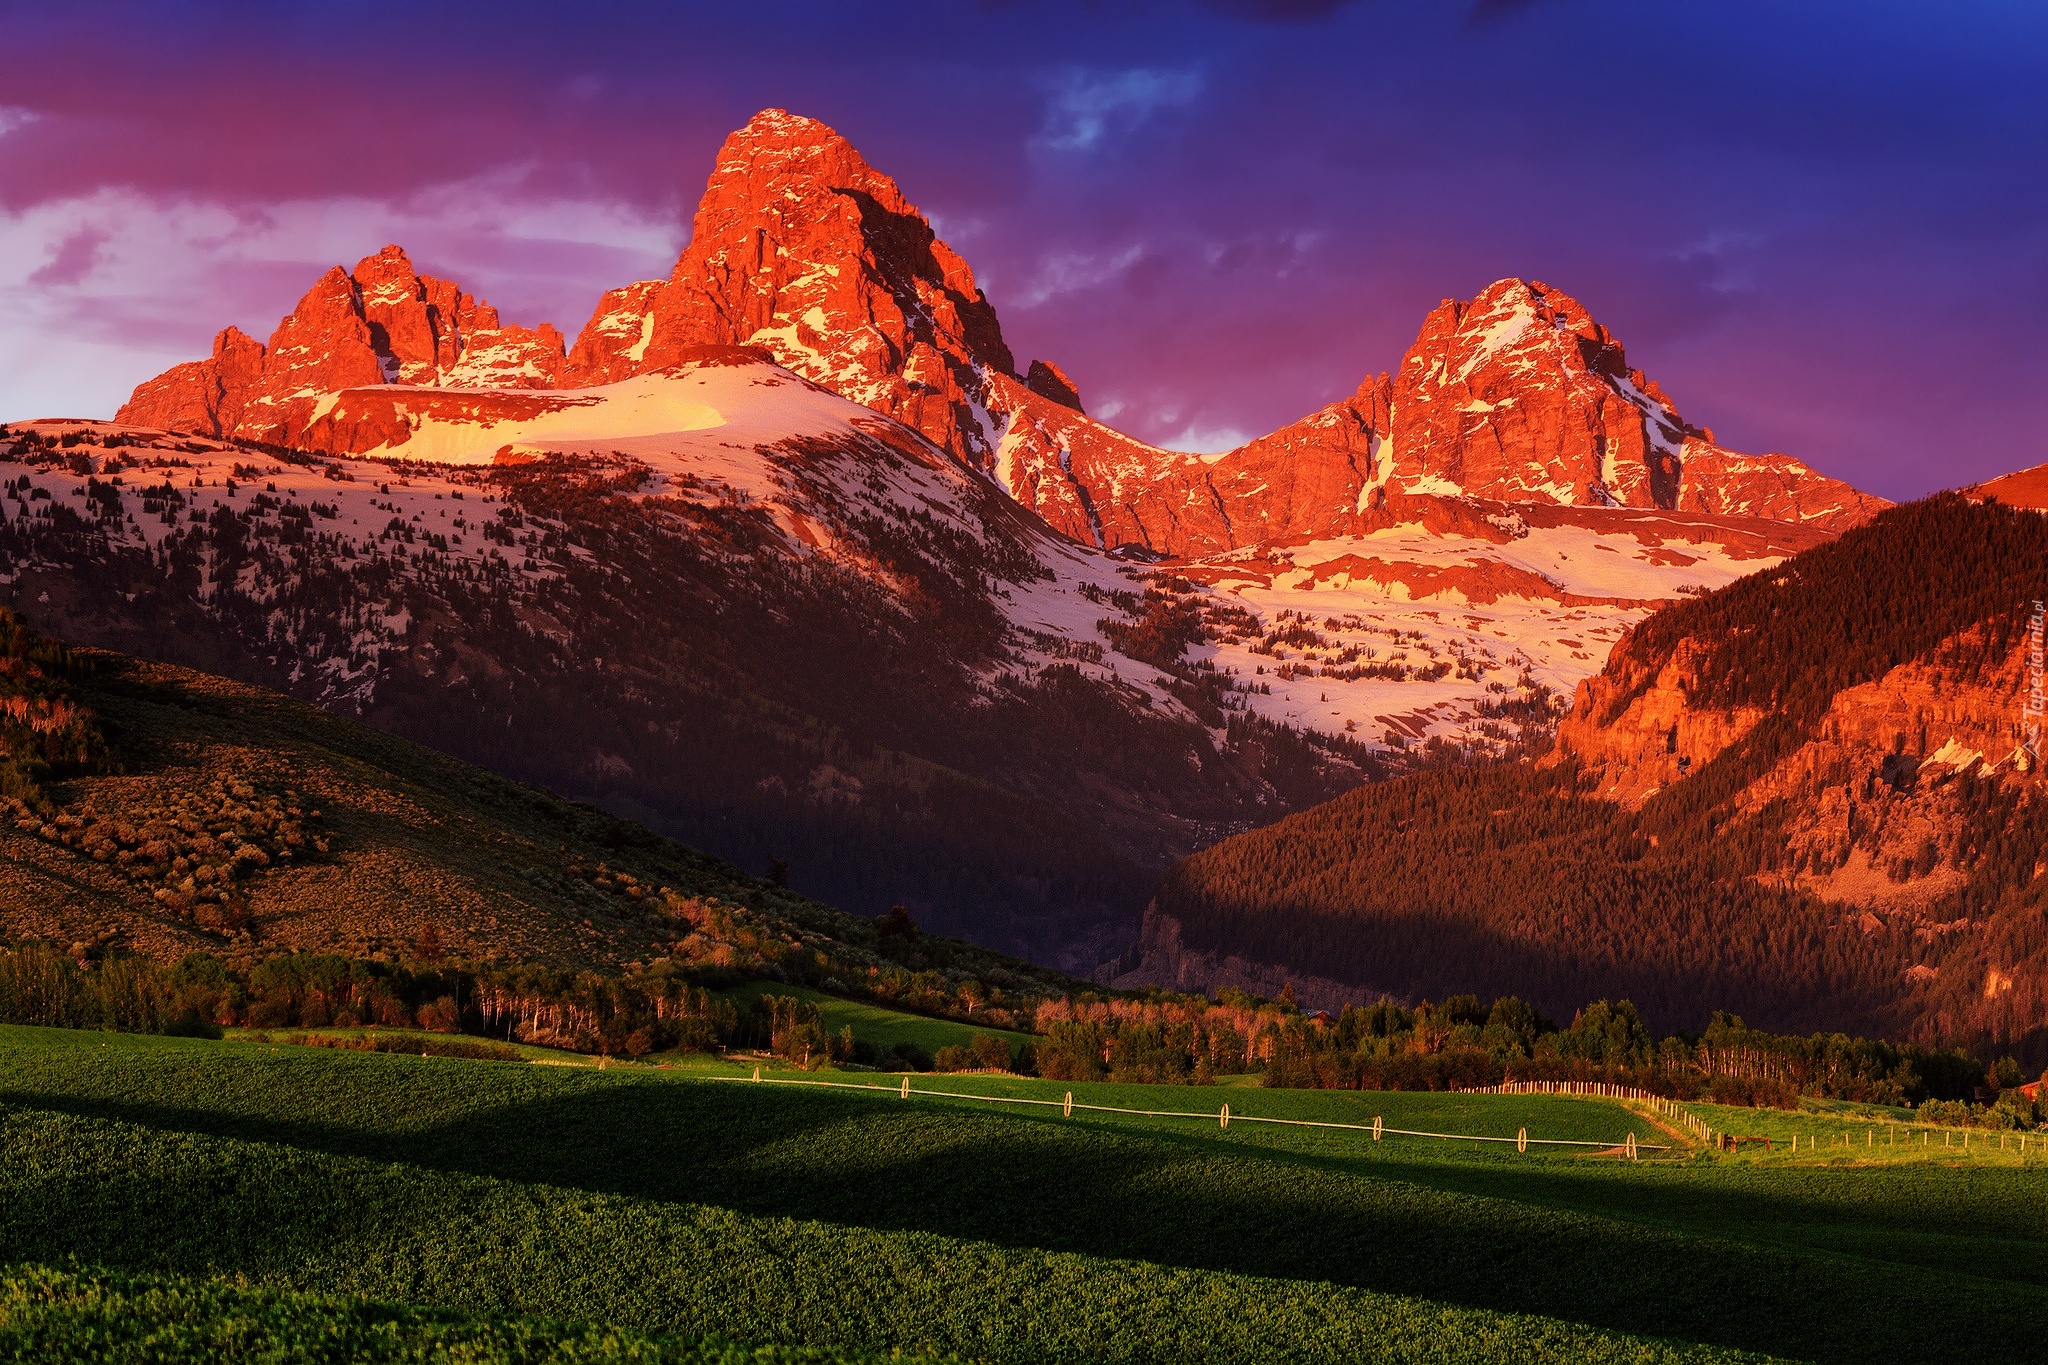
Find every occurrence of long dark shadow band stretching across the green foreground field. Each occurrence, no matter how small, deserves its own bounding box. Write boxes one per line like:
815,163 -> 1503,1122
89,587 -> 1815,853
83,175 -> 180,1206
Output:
0,1078 -> 2048,1361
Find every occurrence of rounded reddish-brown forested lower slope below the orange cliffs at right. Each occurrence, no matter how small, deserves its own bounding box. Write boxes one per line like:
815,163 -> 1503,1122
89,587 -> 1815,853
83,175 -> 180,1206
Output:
1157,763 -> 1898,1029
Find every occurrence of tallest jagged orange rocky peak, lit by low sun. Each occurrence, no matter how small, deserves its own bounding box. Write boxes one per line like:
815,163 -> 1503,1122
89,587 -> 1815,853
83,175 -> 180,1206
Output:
571,108 -> 1012,465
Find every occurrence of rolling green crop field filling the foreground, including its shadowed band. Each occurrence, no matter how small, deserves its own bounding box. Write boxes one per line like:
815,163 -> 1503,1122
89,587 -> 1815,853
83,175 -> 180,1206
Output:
0,1027 -> 2048,1365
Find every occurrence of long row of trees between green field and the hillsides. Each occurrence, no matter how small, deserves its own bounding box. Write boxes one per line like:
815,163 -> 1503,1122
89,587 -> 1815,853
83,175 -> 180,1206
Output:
0,943 -> 2038,1124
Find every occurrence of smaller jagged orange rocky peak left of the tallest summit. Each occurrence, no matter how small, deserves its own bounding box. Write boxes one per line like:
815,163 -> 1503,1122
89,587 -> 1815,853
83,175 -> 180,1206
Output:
117,246 -> 563,444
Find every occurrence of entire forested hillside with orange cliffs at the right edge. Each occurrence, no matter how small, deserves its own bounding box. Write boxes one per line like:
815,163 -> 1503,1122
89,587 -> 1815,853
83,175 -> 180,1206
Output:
1126,495 -> 2048,1064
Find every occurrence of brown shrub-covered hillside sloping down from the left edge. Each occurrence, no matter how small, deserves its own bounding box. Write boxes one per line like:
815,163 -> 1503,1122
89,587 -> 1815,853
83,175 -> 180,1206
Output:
0,612 -> 1075,1015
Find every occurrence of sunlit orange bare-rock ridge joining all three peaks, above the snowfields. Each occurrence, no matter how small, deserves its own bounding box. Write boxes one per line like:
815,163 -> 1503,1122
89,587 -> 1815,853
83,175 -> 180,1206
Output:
117,108 -> 1886,557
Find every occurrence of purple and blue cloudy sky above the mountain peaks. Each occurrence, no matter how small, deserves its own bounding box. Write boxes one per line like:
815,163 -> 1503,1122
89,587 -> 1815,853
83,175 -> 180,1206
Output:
0,0 -> 2048,497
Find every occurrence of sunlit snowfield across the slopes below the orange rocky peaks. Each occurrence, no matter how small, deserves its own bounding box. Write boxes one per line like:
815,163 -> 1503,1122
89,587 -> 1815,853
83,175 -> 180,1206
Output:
0,362 -> 1790,747
